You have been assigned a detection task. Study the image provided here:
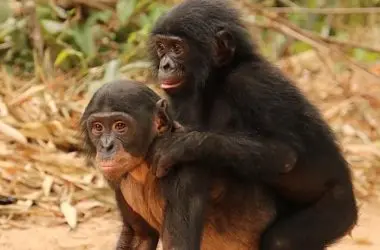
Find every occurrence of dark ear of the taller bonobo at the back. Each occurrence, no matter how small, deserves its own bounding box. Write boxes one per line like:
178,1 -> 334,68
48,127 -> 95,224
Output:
215,30 -> 236,67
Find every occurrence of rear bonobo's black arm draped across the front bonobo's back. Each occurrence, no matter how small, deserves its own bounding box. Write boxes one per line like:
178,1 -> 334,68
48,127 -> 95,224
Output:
152,131 -> 297,178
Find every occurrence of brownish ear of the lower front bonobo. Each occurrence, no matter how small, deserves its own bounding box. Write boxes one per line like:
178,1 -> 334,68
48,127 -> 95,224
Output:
154,99 -> 173,135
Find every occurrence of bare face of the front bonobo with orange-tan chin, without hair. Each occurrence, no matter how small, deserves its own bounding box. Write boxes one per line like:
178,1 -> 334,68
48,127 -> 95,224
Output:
87,112 -> 143,181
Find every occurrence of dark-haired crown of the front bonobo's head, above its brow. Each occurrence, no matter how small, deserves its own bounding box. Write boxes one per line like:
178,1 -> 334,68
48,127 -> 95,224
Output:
83,80 -> 160,117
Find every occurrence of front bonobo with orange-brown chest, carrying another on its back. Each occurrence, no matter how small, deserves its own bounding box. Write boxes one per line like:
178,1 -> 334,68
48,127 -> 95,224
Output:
82,81 -> 284,250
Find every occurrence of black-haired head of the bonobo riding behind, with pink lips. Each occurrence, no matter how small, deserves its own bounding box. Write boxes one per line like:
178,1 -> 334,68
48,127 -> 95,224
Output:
149,0 -> 253,94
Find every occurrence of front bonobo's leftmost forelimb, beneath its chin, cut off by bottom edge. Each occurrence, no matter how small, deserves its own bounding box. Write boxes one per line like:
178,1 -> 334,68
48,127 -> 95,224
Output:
115,189 -> 159,250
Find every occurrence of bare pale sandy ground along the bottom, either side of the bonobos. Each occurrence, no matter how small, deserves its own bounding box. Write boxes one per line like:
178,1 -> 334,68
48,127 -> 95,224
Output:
0,202 -> 380,250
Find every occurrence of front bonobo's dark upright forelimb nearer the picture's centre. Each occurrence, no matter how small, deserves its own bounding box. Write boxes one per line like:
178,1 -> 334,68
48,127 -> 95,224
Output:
160,166 -> 210,250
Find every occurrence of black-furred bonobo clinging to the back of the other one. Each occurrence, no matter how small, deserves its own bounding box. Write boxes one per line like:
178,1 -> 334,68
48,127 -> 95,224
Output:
149,0 -> 357,250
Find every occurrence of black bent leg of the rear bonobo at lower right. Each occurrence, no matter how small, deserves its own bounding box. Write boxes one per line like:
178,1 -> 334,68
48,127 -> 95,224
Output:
261,184 -> 357,250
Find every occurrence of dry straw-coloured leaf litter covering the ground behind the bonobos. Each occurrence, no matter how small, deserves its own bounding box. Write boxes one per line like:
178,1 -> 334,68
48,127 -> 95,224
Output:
0,52 -> 380,227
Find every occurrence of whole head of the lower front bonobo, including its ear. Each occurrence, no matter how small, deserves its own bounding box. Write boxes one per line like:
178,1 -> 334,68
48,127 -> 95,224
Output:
81,81 -> 178,183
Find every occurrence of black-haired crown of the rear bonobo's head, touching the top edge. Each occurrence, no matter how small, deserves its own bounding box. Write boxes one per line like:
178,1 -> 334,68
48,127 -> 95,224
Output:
152,0 -> 239,42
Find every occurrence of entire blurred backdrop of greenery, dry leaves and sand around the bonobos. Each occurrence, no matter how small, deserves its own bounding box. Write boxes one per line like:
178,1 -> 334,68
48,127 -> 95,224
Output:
0,0 -> 380,250
